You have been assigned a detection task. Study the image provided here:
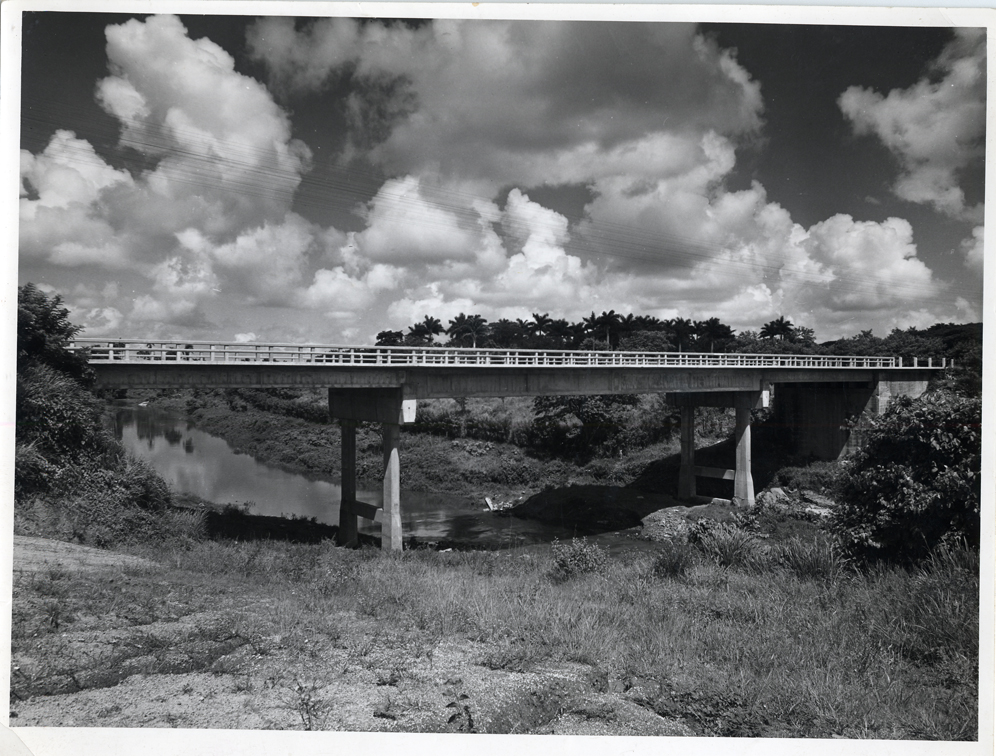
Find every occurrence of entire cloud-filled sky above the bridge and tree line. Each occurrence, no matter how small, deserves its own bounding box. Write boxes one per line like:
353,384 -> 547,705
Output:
18,12 -> 986,344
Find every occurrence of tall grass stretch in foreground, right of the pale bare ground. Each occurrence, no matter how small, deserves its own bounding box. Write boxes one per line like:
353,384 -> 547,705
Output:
128,532 -> 979,739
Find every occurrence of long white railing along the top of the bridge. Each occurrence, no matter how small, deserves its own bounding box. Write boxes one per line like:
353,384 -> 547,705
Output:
72,339 -> 947,369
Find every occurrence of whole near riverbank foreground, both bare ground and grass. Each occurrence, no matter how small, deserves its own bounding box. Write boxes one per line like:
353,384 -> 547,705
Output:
11,528 -> 978,740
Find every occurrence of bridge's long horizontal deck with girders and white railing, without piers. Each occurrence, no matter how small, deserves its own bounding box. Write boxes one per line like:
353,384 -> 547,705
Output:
74,339 -> 946,399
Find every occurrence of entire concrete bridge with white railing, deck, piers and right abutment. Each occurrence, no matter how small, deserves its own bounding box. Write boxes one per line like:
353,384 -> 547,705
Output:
74,339 -> 947,550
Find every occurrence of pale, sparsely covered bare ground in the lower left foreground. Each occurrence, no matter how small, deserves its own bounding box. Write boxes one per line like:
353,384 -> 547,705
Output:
11,536 -> 692,735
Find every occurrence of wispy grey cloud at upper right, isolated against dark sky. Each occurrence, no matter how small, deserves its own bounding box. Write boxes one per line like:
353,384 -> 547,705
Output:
838,29 -> 986,222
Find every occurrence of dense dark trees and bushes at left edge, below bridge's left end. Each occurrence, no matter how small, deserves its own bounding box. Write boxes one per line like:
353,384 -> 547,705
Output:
14,284 -> 175,546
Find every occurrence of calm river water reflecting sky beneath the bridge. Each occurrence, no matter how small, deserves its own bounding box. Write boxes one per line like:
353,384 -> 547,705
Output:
112,406 -> 632,547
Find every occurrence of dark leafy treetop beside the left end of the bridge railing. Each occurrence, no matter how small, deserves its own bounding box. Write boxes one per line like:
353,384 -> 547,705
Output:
17,283 -> 94,385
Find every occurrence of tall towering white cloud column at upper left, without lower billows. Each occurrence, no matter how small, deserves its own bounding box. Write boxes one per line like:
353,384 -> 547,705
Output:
97,16 -> 310,237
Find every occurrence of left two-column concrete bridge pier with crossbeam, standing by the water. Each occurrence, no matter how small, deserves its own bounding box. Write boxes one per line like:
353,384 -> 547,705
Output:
329,388 -> 415,551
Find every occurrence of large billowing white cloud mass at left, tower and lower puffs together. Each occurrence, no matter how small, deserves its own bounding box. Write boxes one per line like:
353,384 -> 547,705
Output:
20,16 -> 344,327
